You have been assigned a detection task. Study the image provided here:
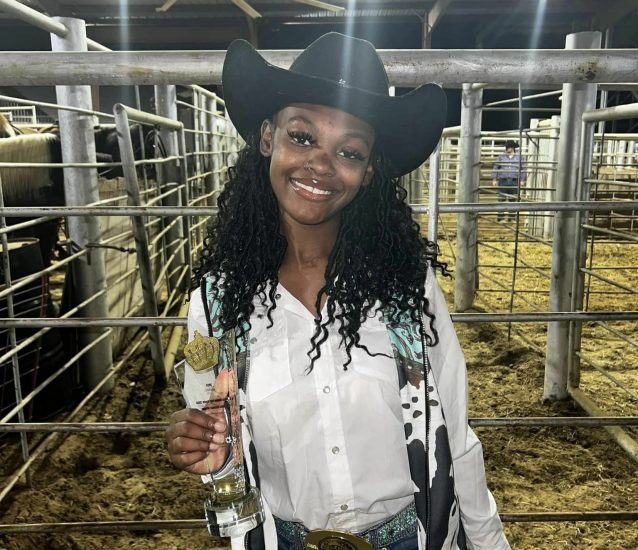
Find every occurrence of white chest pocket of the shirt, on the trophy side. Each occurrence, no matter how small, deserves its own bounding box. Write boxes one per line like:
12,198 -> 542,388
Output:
247,319 -> 292,403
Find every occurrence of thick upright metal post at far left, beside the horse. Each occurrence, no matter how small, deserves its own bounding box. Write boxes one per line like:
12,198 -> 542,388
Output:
51,17 -> 113,391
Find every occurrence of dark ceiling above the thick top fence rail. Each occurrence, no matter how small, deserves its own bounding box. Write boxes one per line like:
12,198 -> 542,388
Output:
0,0 -> 638,50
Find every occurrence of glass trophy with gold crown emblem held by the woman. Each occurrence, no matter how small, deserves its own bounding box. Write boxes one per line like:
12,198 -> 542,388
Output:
176,330 -> 264,537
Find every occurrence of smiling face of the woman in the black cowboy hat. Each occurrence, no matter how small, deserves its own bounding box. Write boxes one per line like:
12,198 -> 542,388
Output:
260,103 -> 374,229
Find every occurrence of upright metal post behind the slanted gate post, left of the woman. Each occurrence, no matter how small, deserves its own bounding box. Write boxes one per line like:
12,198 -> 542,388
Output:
155,86 -> 186,289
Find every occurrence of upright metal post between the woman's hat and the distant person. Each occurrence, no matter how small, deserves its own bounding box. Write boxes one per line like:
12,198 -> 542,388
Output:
454,84 -> 483,311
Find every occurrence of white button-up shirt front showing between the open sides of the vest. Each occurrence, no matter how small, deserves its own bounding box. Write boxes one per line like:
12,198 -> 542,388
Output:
189,285 -> 414,532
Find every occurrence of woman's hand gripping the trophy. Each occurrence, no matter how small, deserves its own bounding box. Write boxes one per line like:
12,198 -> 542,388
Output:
166,408 -> 228,474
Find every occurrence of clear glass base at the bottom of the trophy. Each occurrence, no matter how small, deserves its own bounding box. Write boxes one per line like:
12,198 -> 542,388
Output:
204,487 -> 264,537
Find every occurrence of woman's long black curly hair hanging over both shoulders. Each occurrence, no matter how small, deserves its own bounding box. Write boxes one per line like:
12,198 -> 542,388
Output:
192,129 -> 447,369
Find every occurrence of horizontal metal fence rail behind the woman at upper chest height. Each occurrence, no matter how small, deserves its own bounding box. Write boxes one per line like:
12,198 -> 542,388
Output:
0,311 -> 638,329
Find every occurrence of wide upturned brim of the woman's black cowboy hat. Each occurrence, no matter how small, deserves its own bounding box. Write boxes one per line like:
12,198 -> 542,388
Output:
222,40 -> 447,175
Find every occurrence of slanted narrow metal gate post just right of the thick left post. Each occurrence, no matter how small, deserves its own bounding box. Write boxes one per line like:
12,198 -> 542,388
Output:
113,103 -> 166,386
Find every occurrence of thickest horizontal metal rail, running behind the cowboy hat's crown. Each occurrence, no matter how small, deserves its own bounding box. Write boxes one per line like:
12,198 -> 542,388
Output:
0,48 -> 638,88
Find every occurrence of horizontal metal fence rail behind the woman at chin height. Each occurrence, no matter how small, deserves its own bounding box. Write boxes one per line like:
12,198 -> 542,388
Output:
0,201 -> 638,218
